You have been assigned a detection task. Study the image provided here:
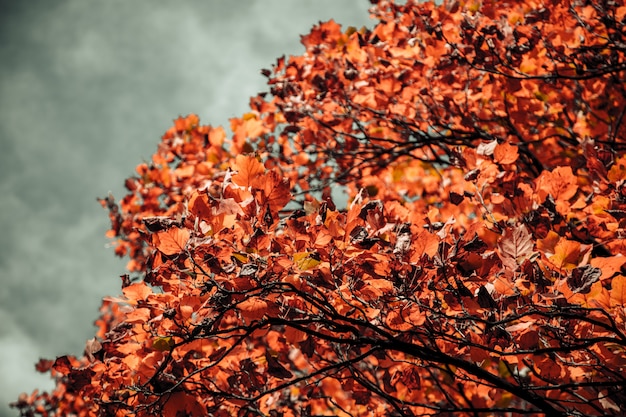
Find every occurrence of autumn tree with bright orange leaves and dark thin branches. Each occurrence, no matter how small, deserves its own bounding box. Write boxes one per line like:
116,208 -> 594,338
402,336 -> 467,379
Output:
14,0 -> 626,416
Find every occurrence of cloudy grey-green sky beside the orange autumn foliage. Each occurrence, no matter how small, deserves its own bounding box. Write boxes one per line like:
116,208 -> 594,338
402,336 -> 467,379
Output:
0,0 -> 372,416
